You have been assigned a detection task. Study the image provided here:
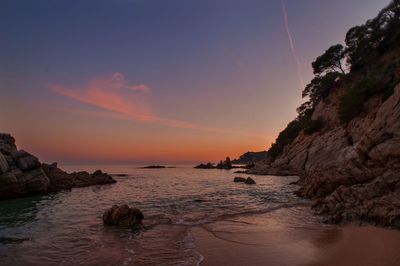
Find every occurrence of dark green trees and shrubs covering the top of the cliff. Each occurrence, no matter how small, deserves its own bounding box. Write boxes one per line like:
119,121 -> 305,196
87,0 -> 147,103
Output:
268,0 -> 400,159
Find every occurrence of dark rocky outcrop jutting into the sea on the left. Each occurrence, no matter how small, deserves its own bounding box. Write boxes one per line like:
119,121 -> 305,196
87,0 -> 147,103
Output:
0,134 -> 116,200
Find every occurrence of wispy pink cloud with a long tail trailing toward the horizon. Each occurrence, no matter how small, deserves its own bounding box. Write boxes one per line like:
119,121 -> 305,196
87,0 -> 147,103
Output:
50,72 -> 268,137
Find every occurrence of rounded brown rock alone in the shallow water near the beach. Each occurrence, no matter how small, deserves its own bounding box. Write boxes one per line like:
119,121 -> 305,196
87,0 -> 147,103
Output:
103,205 -> 144,229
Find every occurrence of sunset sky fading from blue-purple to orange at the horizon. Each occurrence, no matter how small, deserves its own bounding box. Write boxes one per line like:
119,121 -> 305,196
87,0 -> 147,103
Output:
0,0 -> 389,163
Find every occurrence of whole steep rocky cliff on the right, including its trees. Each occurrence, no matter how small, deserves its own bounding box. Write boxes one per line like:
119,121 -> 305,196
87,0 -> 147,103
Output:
247,0 -> 400,228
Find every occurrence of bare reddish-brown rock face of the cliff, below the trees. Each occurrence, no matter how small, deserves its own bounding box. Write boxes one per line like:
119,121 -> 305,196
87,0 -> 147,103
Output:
250,84 -> 400,228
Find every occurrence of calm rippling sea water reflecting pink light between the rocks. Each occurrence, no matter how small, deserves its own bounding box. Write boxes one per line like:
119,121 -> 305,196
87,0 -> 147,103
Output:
0,165 -> 317,265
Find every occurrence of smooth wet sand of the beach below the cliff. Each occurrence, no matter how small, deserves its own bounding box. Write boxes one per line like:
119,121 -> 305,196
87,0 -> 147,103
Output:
191,210 -> 400,266
